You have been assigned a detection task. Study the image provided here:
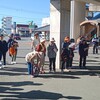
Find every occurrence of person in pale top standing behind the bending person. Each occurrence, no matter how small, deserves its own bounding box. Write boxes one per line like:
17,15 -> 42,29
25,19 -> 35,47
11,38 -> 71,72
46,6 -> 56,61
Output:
31,32 -> 40,50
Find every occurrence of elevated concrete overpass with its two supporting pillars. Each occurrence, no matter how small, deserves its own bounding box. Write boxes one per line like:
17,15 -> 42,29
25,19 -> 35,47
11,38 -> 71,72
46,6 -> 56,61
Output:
50,0 -> 100,68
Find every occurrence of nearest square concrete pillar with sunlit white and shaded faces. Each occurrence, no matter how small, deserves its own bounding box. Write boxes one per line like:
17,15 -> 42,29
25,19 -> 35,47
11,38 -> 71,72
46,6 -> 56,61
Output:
50,0 -> 70,68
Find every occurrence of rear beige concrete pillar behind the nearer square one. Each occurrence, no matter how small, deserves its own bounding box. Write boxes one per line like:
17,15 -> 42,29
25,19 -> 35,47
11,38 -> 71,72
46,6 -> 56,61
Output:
70,0 -> 86,40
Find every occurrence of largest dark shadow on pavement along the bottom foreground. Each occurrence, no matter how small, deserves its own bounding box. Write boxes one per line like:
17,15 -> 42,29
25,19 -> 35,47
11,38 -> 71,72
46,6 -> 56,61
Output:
0,90 -> 82,100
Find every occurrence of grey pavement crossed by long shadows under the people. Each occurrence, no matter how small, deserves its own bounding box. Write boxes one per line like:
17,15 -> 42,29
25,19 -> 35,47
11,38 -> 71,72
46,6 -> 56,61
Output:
0,38 -> 100,100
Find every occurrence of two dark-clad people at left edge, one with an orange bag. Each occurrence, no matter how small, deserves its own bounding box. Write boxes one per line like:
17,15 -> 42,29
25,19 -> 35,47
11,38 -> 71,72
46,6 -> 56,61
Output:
0,34 -> 19,69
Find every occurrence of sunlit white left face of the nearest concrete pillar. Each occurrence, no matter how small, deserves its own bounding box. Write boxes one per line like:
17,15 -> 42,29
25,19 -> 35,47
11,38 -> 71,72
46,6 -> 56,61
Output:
50,0 -> 60,68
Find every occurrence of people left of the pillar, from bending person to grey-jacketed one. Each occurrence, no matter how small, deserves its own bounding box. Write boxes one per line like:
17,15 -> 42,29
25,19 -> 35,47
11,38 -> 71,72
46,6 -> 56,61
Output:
25,33 -> 58,77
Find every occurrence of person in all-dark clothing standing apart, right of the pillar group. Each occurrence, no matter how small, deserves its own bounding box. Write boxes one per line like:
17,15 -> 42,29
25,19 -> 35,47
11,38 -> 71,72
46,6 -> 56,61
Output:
79,39 -> 89,68
